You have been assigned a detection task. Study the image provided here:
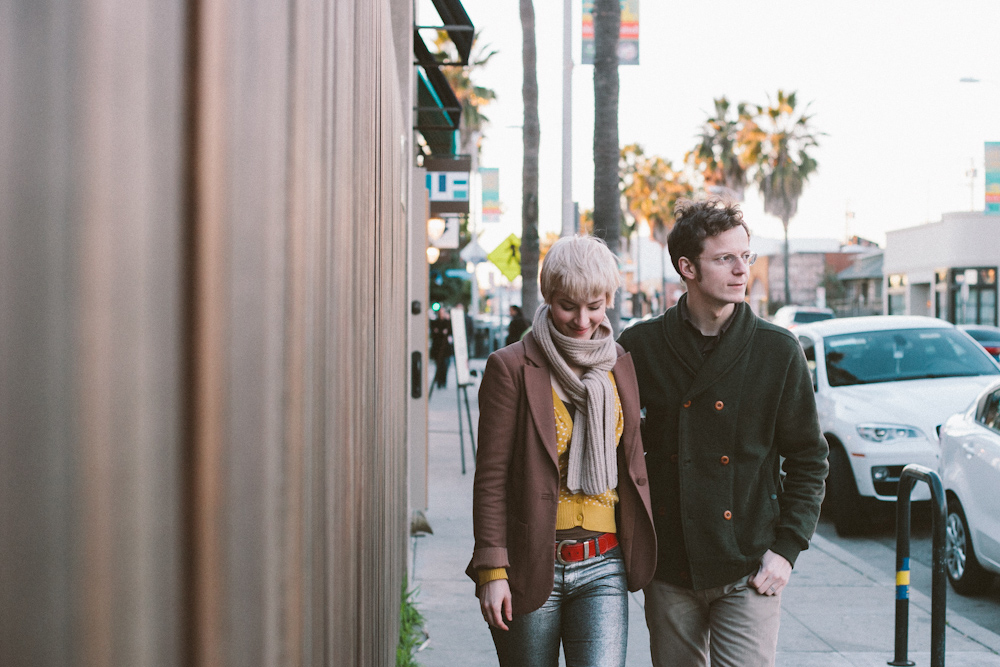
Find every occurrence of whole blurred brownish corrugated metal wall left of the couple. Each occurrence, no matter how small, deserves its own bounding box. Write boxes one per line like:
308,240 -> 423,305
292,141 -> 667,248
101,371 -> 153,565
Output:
0,0 -> 412,667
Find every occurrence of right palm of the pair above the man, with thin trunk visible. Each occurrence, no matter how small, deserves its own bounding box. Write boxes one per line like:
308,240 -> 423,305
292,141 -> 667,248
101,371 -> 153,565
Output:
742,90 -> 823,304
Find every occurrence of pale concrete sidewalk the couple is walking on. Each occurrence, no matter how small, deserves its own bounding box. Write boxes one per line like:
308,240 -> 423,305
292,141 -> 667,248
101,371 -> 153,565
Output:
411,359 -> 1000,667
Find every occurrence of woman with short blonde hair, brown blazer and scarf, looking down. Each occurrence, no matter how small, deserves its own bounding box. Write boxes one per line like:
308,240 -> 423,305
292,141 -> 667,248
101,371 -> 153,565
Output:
466,237 -> 656,667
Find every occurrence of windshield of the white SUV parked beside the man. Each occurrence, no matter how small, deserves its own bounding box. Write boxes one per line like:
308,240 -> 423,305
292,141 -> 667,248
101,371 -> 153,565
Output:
823,329 -> 1000,387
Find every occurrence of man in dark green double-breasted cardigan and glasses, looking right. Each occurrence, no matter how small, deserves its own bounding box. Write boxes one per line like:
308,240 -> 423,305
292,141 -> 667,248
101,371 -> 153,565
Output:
619,201 -> 829,667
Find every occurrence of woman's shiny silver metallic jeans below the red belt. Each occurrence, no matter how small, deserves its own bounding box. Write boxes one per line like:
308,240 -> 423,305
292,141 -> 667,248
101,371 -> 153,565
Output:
490,546 -> 628,667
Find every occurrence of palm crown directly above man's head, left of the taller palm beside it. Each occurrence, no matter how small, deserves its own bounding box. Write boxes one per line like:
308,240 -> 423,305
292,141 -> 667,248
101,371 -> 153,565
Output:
684,97 -> 752,201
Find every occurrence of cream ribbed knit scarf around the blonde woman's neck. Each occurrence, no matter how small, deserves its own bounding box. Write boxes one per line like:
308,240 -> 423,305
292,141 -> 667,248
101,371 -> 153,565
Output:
531,303 -> 618,496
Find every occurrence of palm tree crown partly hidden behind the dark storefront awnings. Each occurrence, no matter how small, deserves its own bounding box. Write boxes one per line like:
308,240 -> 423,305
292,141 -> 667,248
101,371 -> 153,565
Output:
434,30 -> 497,155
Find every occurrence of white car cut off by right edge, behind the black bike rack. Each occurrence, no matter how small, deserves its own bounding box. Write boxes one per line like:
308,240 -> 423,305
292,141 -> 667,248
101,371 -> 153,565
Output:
941,383 -> 1000,595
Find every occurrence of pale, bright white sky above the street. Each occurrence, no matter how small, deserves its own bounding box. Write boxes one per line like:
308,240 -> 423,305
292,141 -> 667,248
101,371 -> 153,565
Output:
418,0 -> 1000,258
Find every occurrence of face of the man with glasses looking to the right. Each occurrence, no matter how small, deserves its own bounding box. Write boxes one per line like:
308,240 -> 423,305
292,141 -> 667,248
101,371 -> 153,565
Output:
681,225 -> 750,306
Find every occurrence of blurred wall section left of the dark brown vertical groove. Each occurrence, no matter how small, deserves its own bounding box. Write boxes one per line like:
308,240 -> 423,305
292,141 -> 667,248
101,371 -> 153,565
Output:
0,0 -> 183,665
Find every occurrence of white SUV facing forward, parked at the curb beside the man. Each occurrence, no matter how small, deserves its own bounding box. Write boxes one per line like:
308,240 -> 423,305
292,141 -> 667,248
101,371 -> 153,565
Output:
795,315 -> 1000,535
